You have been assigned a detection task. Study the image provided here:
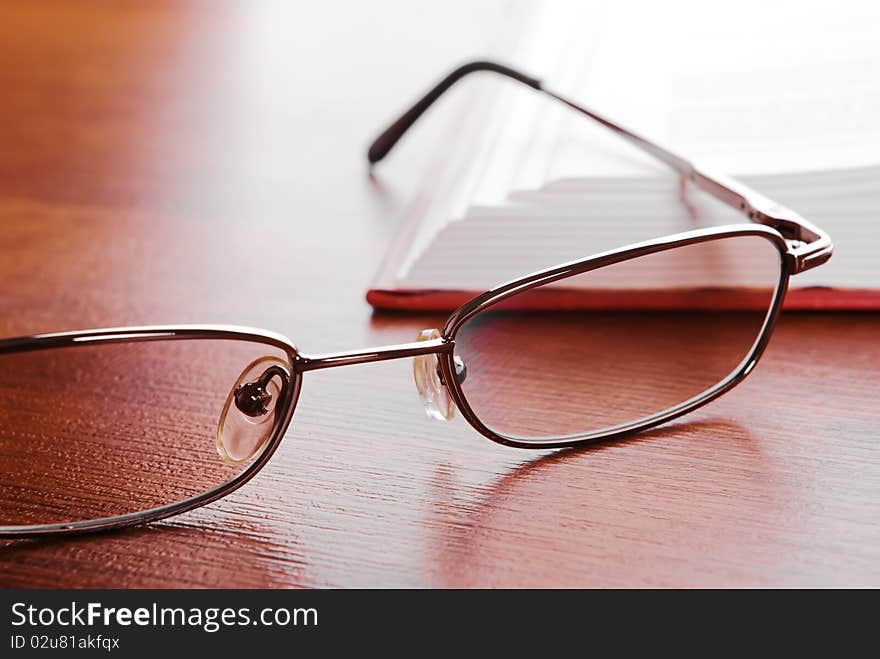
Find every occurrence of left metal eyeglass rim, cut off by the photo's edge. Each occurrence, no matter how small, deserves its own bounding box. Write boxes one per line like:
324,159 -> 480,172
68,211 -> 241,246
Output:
0,325 -> 302,540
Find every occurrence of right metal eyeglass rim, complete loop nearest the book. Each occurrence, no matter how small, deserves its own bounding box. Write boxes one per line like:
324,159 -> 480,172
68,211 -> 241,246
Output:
438,224 -> 796,449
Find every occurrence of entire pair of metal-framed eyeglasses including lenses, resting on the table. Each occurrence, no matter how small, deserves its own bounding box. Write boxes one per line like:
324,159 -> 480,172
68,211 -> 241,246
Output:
0,62 -> 832,538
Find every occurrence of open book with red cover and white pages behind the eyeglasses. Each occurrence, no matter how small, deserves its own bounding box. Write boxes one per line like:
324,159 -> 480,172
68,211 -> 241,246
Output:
367,2 -> 880,310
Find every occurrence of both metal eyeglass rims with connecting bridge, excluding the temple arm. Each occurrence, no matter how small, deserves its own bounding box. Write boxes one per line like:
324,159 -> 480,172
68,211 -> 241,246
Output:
0,224 -> 797,539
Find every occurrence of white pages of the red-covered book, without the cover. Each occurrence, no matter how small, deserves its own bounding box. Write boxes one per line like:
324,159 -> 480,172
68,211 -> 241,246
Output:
399,0 -> 880,290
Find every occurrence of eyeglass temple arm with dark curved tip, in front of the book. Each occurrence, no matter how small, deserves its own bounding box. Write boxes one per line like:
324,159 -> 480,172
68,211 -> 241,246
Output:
367,61 -> 833,272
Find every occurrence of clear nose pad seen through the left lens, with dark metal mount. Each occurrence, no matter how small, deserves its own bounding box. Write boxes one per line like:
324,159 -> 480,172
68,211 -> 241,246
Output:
217,357 -> 290,464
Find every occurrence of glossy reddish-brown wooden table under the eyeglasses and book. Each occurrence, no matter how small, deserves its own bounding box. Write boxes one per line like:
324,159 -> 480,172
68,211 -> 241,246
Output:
0,1 -> 880,587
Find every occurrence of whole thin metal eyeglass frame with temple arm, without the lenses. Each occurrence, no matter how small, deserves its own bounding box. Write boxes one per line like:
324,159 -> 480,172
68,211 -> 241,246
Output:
0,61 -> 833,538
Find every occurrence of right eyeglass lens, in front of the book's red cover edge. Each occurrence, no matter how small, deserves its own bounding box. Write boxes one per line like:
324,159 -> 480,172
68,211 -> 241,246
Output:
455,235 -> 781,439
